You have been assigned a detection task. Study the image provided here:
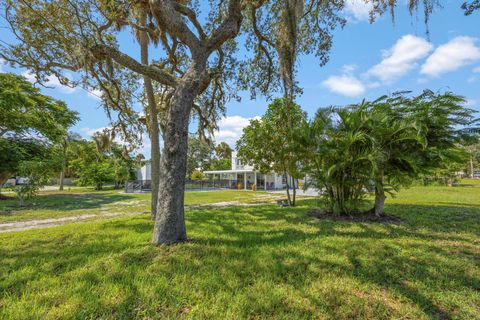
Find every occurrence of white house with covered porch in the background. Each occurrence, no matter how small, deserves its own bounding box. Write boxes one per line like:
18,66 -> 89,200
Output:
204,152 -> 286,190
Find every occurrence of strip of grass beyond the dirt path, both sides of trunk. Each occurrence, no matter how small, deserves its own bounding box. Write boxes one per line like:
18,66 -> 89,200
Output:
0,188 -> 278,223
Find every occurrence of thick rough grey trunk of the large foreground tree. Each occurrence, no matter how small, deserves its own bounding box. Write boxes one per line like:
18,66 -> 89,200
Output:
152,77 -> 201,245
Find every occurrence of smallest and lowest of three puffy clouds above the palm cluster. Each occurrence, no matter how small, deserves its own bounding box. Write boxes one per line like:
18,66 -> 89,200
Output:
322,70 -> 366,97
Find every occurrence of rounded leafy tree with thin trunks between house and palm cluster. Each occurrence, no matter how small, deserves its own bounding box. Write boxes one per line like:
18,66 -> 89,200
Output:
237,98 -> 306,206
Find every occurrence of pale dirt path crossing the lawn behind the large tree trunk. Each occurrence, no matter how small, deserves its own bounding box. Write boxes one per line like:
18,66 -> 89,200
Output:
0,201 -> 276,233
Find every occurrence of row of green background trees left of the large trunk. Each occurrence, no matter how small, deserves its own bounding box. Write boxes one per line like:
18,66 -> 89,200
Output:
0,73 -> 138,204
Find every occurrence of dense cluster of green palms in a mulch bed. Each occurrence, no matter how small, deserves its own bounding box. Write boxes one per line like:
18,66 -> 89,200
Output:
297,91 -> 475,215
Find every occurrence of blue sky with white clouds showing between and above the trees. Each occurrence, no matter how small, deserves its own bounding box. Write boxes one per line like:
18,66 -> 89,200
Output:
0,0 -> 480,158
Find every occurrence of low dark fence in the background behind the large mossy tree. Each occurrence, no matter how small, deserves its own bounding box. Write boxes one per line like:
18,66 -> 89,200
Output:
125,179 -> 237,193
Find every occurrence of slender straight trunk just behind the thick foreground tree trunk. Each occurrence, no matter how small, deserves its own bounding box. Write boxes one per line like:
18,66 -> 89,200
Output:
140,10 -> 160,220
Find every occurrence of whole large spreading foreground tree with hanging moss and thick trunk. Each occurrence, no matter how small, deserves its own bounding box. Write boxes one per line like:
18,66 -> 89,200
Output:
1,0 -> 437,244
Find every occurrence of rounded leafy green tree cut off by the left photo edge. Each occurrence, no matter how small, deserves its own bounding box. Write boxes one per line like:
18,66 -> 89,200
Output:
0,73 -> 78,190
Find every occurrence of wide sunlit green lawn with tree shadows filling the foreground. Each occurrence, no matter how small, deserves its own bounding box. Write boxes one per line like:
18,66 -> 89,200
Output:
0,181 -> 480,319
